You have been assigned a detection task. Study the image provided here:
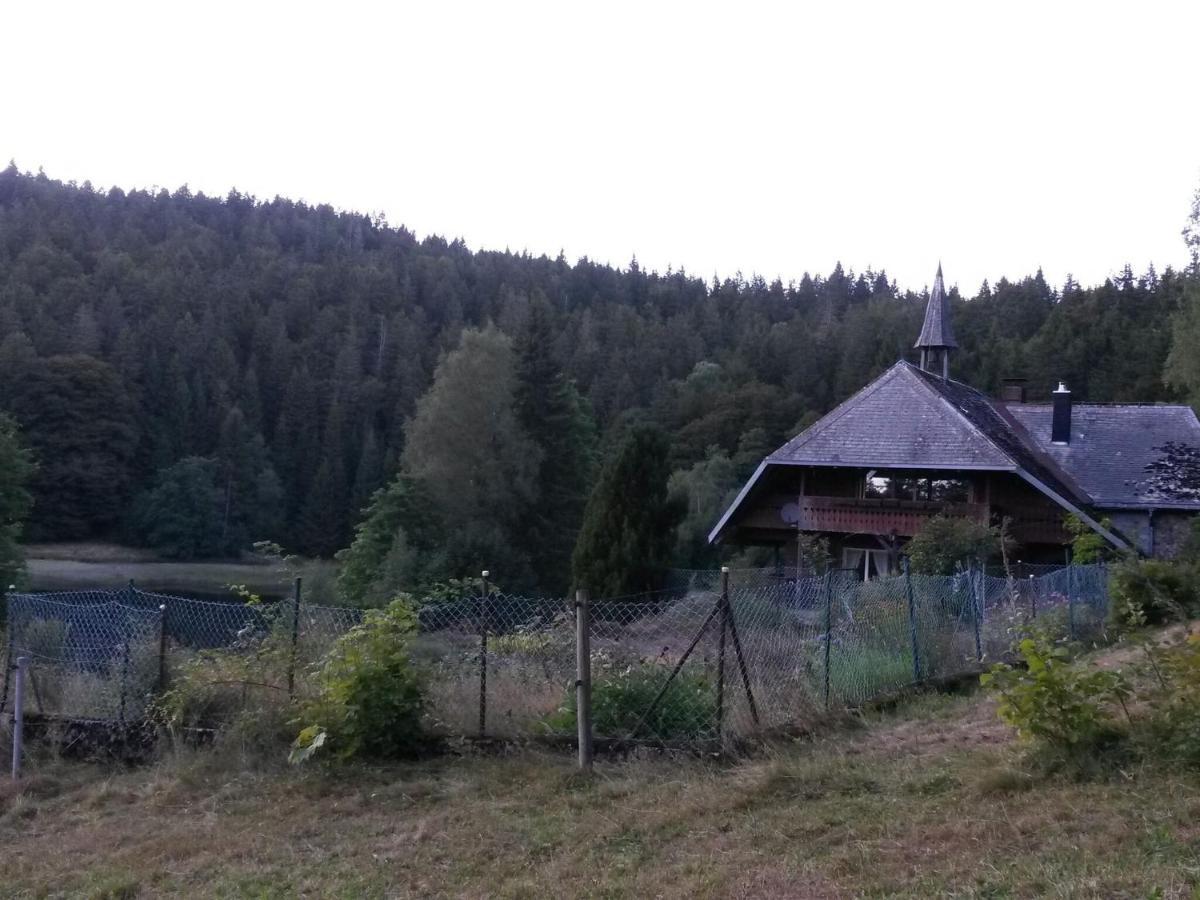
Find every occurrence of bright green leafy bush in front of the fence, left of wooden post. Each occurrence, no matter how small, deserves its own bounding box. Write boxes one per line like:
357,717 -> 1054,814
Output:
290,599 -> 427,762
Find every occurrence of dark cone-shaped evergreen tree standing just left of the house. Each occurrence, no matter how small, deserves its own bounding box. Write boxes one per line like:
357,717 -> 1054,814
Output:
571,426 -> 683,598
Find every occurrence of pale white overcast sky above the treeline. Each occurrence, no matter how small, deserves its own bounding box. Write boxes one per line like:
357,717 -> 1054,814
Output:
0,0 -> 1200,293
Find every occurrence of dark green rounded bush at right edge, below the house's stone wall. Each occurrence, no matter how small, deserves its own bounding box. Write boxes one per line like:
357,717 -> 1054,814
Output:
1109,559 -> 1200,631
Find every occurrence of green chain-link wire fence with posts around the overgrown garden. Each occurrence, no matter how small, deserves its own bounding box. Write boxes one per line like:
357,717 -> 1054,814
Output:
2,566 -> 1108,749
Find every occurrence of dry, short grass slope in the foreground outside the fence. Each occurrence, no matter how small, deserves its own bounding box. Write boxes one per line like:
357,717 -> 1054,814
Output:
0,698 -> 1200,898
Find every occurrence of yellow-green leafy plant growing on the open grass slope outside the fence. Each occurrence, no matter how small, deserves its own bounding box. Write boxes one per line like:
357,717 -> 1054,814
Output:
979,635 -> 1130,756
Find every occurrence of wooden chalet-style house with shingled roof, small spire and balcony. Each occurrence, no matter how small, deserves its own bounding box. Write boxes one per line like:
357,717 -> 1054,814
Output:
709,266 -> 1200,578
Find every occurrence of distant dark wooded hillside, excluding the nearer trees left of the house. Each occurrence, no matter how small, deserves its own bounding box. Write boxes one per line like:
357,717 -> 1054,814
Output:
0,166 -> 1186,592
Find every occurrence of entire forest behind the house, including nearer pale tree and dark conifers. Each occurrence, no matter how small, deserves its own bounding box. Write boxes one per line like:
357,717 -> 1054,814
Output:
0,164 -> 1200,601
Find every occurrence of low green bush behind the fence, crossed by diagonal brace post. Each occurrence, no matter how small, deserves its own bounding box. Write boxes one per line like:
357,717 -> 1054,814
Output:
546,659 -> 710,740
